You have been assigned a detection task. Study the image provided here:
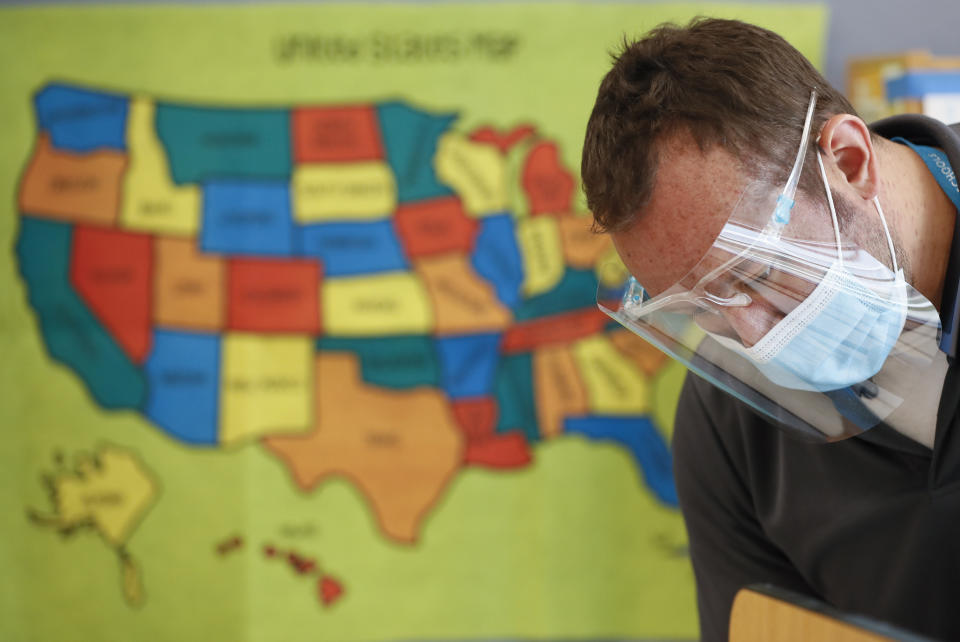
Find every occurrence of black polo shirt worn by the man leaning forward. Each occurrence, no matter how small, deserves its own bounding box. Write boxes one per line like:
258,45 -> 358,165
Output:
673,116 -> 960,642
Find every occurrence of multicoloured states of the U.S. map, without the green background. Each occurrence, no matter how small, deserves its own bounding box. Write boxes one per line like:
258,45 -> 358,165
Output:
15,83 -> 676,602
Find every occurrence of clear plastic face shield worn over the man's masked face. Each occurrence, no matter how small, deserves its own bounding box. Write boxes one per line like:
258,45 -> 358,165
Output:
598,92 -> 940,441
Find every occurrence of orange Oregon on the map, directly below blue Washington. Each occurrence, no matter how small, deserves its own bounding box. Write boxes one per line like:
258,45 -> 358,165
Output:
18,133 -> 127,225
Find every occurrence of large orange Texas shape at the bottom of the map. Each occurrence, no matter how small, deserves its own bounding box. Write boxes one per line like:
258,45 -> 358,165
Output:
263,352 -> 463,543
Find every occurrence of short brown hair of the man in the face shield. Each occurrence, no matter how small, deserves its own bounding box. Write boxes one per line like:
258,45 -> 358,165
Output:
580,18 -> 856,231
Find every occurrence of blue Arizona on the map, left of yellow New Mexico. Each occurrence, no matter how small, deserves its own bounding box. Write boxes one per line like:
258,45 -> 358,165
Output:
143,330 -> 220,446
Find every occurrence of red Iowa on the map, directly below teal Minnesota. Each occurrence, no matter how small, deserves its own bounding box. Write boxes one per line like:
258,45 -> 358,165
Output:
393,196 -> 477,258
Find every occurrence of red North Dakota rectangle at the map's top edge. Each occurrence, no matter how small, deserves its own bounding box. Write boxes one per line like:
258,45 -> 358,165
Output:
291,106 -> 384,163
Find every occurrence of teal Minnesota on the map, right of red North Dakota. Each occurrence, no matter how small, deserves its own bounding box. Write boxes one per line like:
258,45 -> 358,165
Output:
377,102 -> 457,203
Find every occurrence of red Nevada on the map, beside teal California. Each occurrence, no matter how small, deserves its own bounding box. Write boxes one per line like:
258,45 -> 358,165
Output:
70,225 -> 153,363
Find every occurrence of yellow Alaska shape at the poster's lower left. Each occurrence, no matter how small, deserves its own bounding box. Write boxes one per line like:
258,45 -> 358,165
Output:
47,446 -> 157,548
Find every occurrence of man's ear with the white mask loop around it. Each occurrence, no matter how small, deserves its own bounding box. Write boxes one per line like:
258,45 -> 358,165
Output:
818,114 -> 879,200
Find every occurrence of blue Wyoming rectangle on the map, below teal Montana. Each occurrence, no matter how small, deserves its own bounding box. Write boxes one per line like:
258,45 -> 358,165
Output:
200,181 -> 294,256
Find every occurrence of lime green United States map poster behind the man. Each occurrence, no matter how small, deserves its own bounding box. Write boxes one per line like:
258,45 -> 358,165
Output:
0,4 -> 824,641
